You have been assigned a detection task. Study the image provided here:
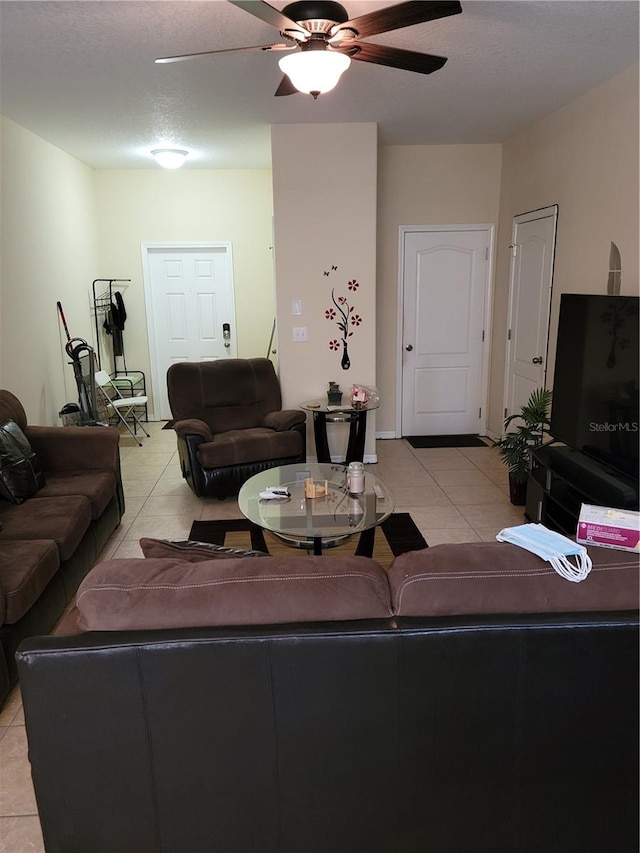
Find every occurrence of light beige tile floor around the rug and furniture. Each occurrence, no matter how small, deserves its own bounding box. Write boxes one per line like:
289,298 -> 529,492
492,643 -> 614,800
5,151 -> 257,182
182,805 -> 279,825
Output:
0,423 -> 523,853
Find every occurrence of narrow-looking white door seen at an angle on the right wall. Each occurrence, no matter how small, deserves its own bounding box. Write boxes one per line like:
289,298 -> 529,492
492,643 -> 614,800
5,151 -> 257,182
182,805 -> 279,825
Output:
504,205 -> 558,417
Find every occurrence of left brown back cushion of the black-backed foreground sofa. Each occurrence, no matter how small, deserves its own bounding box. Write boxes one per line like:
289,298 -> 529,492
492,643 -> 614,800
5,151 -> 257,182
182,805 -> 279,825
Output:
76,555 -> 391,631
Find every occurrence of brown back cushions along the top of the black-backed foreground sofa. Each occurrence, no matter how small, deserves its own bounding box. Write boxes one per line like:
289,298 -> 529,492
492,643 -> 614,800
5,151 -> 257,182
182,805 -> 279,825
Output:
76,539 -> 640,631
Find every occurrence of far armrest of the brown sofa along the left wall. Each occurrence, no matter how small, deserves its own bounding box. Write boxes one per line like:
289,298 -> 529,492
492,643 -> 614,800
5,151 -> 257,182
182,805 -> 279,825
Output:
25,426 -> 120,477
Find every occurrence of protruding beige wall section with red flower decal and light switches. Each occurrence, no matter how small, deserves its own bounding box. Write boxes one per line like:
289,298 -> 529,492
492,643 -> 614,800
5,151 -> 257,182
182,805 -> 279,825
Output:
271,123 -> 377,459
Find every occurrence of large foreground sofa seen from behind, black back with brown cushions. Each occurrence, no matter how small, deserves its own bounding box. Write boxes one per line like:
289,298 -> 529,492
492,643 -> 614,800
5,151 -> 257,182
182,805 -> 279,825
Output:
18,543 -> 638,853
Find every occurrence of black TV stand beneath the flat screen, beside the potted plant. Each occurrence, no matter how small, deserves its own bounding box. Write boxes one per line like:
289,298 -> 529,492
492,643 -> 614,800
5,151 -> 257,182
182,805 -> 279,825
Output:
525,445 -> 638,536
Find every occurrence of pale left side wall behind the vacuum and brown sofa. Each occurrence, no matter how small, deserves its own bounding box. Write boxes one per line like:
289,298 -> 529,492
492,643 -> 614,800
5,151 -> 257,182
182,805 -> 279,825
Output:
0,119 -> 97,424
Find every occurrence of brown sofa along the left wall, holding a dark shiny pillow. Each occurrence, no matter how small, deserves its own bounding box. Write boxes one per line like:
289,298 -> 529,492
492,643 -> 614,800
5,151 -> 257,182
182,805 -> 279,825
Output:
0,390 -> 124,707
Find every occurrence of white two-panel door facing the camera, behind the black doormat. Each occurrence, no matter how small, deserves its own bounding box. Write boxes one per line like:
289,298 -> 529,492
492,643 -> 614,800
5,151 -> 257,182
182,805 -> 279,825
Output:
401,226 -> 491,435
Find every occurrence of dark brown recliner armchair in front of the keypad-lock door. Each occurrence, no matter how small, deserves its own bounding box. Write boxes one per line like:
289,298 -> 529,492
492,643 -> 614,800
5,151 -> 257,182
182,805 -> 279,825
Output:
167,358 -> 307,499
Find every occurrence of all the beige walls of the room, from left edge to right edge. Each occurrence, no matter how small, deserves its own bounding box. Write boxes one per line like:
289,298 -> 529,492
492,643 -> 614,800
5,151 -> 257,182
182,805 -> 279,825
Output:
0,67 -> 639,436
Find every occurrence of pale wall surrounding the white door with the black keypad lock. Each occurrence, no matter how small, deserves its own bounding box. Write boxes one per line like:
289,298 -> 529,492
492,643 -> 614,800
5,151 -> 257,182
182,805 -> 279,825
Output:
93,169 -> 275,412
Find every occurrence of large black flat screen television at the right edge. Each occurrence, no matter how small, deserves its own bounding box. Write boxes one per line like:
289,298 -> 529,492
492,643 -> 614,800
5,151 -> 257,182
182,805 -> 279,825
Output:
549,293 -> 640,481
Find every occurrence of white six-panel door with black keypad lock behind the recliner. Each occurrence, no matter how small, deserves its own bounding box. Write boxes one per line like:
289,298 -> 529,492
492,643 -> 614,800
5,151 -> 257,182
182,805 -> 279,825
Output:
143,243 -> 237,419
